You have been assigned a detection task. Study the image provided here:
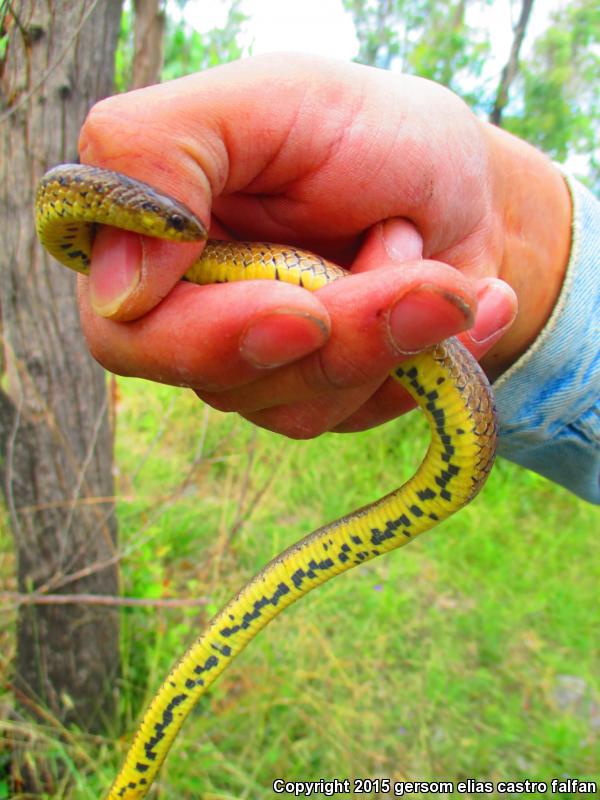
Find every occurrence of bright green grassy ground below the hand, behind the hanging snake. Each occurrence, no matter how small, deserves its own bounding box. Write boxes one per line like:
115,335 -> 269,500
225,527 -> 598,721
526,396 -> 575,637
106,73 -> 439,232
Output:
0,380 -> 600,800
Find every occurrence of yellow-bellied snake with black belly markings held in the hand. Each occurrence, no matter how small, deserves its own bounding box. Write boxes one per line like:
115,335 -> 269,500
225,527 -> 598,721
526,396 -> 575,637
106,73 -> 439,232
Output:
36,164 -> 497,800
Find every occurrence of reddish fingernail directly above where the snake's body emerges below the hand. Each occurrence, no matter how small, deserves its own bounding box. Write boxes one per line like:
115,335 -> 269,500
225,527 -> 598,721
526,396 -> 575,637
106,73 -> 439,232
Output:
389,286 -> 473,353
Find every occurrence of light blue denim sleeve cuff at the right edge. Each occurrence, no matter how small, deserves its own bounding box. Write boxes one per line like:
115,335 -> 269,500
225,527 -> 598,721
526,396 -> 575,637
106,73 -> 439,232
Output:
494,176 -> 600,503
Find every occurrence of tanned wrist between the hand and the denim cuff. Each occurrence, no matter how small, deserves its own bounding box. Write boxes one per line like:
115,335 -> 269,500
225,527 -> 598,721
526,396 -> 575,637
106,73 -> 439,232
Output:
483,123 -> 572,377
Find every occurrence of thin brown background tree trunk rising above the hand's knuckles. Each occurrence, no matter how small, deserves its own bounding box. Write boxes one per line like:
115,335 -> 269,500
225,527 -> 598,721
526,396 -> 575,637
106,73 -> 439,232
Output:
131,0 -> 165,89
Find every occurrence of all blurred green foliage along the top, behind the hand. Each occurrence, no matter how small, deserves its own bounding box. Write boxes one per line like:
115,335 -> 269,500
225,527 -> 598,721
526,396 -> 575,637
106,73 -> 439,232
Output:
116,0 -> 600,189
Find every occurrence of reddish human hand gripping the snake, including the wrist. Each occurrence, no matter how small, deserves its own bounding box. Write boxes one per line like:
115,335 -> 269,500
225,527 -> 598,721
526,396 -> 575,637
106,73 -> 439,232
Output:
80,55 -> 569,437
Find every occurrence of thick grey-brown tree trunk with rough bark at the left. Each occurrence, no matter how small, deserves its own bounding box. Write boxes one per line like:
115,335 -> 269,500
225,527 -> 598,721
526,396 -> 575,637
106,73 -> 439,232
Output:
0,0 -> 121,752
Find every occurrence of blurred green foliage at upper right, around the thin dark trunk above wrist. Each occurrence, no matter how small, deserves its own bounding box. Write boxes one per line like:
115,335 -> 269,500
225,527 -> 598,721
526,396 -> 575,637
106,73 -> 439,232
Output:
343,0 -> 600,189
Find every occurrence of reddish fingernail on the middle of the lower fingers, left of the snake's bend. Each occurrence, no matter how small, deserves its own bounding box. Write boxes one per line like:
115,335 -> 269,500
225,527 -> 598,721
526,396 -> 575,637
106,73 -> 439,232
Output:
240,310 -> 328,369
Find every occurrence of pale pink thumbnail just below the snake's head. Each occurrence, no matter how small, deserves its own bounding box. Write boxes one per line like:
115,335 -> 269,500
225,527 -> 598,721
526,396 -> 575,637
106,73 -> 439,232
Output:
90,229 -> 142,317
